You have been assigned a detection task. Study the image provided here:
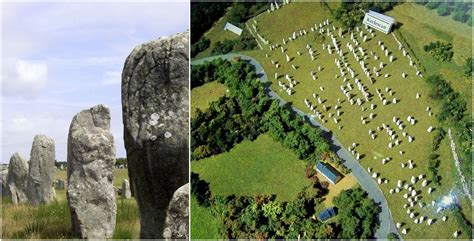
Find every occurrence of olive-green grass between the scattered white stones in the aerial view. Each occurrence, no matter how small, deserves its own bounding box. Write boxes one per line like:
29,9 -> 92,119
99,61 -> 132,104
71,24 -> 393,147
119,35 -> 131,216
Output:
244,3 -> 471,239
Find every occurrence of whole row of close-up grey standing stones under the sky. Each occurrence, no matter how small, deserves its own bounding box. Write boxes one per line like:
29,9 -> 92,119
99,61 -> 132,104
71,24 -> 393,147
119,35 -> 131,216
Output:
2,32 -> 189,239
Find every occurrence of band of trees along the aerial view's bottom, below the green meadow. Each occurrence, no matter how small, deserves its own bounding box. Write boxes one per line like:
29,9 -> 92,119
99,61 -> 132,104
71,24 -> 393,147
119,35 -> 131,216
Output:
191,173 -> 381,239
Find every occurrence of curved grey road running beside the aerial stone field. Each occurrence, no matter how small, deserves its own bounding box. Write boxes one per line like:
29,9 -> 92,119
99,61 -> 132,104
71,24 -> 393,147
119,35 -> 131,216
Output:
191,54 -> 401,239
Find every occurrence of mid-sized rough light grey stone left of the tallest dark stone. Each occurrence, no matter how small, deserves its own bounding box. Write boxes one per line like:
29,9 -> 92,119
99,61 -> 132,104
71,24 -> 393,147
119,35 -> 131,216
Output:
67,105 -> 117,239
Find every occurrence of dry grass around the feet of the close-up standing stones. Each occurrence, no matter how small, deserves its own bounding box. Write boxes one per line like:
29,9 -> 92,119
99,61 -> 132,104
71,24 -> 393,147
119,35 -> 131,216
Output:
0,169 -> 140,239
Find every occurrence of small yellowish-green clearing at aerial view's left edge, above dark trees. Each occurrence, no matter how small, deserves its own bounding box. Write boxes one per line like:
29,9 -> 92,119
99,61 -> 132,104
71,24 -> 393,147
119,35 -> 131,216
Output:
191,81 -> 226,117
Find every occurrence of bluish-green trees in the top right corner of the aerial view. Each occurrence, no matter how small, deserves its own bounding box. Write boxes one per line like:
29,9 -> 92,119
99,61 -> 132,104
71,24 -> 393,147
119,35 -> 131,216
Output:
415,0 -> 472,26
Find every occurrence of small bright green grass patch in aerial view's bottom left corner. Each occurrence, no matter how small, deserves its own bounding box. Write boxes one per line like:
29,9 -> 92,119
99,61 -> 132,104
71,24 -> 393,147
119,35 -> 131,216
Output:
191,197 -> 220,239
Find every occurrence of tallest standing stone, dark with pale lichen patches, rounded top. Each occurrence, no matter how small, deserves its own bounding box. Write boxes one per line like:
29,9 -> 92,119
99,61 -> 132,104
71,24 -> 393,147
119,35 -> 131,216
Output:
122,32 -> 189,238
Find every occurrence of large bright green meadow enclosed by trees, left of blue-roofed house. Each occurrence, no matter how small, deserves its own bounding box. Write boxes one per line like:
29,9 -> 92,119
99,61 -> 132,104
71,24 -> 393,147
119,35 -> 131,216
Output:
191,134 -> 310,200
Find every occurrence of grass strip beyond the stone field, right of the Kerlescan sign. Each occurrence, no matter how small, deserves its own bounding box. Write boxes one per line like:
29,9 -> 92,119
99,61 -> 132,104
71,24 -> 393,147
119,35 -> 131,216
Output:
388,3 -> 473,109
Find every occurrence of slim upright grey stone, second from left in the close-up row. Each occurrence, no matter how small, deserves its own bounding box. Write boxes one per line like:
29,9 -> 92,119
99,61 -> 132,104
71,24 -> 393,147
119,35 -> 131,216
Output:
27,135 -> 55,205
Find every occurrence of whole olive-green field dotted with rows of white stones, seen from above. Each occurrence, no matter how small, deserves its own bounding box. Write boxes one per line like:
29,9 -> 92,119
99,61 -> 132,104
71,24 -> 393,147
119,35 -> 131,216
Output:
191,1 -> 472,239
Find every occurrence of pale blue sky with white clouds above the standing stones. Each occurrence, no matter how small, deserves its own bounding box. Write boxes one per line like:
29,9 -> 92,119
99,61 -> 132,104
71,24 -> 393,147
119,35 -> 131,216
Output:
1,2 -> 189,163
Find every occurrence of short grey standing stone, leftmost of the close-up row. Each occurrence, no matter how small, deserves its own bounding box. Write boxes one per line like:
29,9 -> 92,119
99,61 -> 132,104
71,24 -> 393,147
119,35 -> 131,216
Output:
5,153 -> 28,205
